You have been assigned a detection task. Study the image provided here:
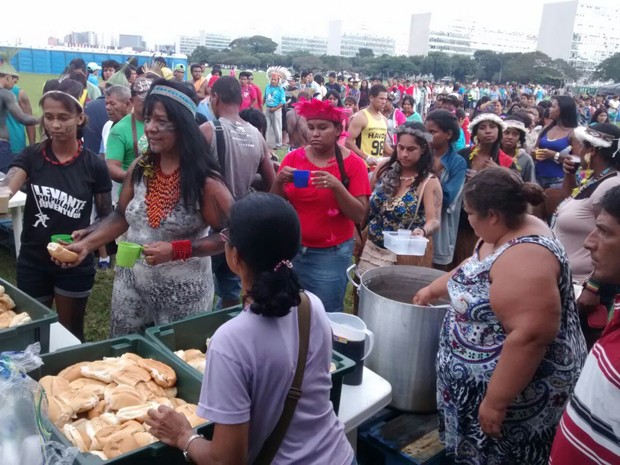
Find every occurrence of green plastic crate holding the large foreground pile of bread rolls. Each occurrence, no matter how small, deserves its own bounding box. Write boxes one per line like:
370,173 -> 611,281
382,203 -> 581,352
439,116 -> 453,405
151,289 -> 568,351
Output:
29,336 -> 213,465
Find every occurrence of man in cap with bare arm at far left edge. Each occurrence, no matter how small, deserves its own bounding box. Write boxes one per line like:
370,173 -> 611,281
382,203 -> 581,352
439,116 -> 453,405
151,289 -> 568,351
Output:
0,58 -> 39,173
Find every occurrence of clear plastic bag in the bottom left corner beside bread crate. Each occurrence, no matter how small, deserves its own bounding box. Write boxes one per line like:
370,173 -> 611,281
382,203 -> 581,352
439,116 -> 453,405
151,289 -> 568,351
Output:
0,343 -> 78,465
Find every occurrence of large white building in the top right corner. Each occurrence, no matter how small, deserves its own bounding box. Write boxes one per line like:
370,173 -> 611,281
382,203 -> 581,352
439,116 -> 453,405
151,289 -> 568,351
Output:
537,0 -> 620,73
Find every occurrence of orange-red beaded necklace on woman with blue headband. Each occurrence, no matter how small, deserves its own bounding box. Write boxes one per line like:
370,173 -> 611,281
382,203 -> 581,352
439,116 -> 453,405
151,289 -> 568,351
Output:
145,164 -> 181,229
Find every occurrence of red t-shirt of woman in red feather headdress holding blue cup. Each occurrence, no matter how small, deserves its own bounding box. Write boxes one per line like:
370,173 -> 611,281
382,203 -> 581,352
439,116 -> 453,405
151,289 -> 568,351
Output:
280,147 -> 371,248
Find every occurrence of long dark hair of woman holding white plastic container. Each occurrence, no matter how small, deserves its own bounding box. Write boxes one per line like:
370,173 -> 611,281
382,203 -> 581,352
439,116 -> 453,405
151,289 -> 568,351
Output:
377,123 -> 433,195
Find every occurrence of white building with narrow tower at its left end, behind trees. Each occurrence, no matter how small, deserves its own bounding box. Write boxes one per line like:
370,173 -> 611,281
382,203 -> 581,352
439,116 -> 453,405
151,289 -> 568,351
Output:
409,13 -> 536,56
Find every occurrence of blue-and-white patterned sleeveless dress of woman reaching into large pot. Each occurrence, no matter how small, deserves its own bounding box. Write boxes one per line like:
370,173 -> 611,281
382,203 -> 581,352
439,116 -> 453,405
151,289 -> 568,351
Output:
437,236 -> 587,465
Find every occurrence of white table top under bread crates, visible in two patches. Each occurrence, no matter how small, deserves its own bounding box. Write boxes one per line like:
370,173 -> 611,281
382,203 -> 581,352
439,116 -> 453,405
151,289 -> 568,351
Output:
50,323 -> 392,433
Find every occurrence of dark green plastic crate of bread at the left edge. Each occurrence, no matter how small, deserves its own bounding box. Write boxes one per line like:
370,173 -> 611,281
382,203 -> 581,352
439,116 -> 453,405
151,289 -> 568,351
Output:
0,279 -> 58,354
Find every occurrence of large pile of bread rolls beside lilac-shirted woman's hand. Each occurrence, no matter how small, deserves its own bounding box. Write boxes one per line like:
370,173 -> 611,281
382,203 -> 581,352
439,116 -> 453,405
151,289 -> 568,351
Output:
39,353 -> 207,460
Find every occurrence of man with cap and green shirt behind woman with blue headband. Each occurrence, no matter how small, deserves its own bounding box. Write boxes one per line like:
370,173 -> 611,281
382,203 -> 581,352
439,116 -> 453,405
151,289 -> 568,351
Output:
105,77 -> 151,184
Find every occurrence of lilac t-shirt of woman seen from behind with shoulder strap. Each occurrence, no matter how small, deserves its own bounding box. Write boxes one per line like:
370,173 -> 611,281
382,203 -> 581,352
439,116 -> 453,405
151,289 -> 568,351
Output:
197,293 -> 353,465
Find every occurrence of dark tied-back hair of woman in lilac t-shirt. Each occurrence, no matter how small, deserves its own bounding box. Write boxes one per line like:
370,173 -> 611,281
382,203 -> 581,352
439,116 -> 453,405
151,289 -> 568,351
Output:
229,192 -> 301,317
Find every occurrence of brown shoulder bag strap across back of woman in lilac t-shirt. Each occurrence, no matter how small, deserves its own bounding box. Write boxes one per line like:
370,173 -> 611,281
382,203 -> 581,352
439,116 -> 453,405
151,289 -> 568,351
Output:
253,292 -> 311,465
